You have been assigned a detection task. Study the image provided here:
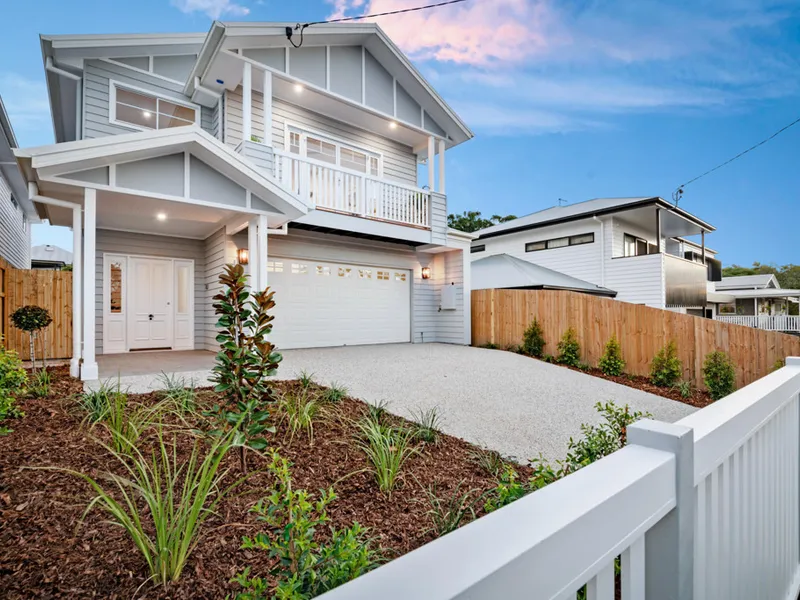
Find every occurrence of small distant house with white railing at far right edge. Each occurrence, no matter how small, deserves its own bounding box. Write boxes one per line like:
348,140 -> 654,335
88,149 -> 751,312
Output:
715,274 -> 800,333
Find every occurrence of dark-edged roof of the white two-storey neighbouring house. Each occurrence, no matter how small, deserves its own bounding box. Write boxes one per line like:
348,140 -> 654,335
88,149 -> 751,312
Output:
476,196 -> 714,239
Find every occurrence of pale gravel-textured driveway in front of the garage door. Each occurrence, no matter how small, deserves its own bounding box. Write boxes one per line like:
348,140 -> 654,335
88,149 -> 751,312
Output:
278,344 -> 696,460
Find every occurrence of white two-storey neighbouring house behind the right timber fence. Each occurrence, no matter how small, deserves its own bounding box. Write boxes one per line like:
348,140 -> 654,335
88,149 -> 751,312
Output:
471,197 -> 721,316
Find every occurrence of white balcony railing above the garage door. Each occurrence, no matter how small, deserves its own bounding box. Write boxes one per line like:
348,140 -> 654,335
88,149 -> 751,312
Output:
275,150 -> 430,228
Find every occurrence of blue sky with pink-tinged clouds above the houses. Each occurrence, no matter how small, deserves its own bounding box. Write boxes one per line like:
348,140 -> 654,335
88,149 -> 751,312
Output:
0,0 -> 800,265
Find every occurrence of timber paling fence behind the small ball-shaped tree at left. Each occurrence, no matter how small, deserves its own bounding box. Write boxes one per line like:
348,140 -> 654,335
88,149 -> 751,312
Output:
0,259 -> 72,360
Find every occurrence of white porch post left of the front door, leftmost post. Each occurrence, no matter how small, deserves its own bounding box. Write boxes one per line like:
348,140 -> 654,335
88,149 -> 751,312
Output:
81,188 -> 99,381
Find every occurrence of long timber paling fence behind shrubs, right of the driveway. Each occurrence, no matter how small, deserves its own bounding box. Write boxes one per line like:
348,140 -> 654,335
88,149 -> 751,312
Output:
472,290 -> 800,387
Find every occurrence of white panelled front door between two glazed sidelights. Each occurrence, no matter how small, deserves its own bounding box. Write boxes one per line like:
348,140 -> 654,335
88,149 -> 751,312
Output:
128,257 -> 173,350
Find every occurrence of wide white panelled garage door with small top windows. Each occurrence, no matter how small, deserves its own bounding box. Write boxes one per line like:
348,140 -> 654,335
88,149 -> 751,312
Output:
267,258 -> 411,349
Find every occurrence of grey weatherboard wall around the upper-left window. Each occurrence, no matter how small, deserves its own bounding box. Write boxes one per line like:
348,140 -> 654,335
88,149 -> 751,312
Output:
83,60 -> 216,139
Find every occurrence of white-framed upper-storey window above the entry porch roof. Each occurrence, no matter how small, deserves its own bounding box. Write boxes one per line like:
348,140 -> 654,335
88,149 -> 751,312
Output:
111,83 -> 198,129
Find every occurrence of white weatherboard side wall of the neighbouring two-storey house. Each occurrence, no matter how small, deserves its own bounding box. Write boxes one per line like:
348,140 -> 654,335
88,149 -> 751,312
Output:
471,219 -> 604,289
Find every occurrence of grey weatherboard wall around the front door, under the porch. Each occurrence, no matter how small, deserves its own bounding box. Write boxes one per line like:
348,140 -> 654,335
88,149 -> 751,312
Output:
95,229 -> 206,354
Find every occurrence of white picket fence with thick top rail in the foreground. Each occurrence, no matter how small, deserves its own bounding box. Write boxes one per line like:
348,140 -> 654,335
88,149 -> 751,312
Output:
322,358 -> 800,600
